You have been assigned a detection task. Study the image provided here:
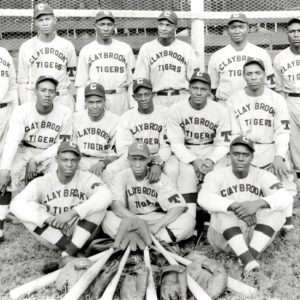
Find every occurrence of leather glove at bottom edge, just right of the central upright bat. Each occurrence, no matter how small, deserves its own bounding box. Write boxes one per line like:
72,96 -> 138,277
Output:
159,265 -> 187,300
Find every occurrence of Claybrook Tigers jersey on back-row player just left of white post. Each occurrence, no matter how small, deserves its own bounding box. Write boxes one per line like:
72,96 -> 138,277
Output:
134,39 -> 198,92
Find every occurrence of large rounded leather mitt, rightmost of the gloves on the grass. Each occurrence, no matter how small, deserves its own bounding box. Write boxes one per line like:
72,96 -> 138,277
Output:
186,253 -> 227,299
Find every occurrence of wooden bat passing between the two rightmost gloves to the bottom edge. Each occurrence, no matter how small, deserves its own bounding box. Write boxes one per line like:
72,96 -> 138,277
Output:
151,234 -> 212,300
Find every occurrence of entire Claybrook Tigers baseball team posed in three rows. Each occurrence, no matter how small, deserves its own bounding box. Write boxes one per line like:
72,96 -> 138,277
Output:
0,3 -> 300,288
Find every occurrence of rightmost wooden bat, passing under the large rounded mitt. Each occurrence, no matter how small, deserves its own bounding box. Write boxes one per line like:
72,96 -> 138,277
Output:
152,247 -> 257,297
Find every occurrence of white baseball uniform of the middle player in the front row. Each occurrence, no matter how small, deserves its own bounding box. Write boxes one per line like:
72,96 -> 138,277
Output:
102,168 -> 196,243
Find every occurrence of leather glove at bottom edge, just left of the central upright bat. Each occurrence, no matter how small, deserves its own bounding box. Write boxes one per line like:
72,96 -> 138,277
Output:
120,263 -> 150,300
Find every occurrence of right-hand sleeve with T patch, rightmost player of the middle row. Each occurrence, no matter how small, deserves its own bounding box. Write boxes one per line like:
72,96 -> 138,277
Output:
274,94 -> 291,158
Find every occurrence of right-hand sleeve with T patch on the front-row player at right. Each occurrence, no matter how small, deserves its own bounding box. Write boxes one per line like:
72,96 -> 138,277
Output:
260,171 -> 293,210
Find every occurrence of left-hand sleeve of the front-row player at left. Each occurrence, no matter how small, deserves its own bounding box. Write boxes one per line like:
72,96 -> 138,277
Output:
10,178 -> 51,227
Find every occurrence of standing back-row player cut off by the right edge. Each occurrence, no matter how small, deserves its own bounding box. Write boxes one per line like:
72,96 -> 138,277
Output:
274,17 -> 300,188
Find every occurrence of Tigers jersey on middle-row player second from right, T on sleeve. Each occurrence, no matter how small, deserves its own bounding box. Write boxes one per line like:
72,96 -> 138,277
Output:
167,100 -> 231,163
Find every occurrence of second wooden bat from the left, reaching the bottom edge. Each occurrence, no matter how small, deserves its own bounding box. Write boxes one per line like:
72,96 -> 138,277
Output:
62,247 -> 114,300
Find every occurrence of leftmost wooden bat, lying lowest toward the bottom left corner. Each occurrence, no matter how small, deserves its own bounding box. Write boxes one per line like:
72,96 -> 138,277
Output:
9,249 -> 109,300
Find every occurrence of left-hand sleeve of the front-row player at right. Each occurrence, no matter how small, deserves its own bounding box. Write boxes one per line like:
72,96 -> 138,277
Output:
197,171 -> 234,213
